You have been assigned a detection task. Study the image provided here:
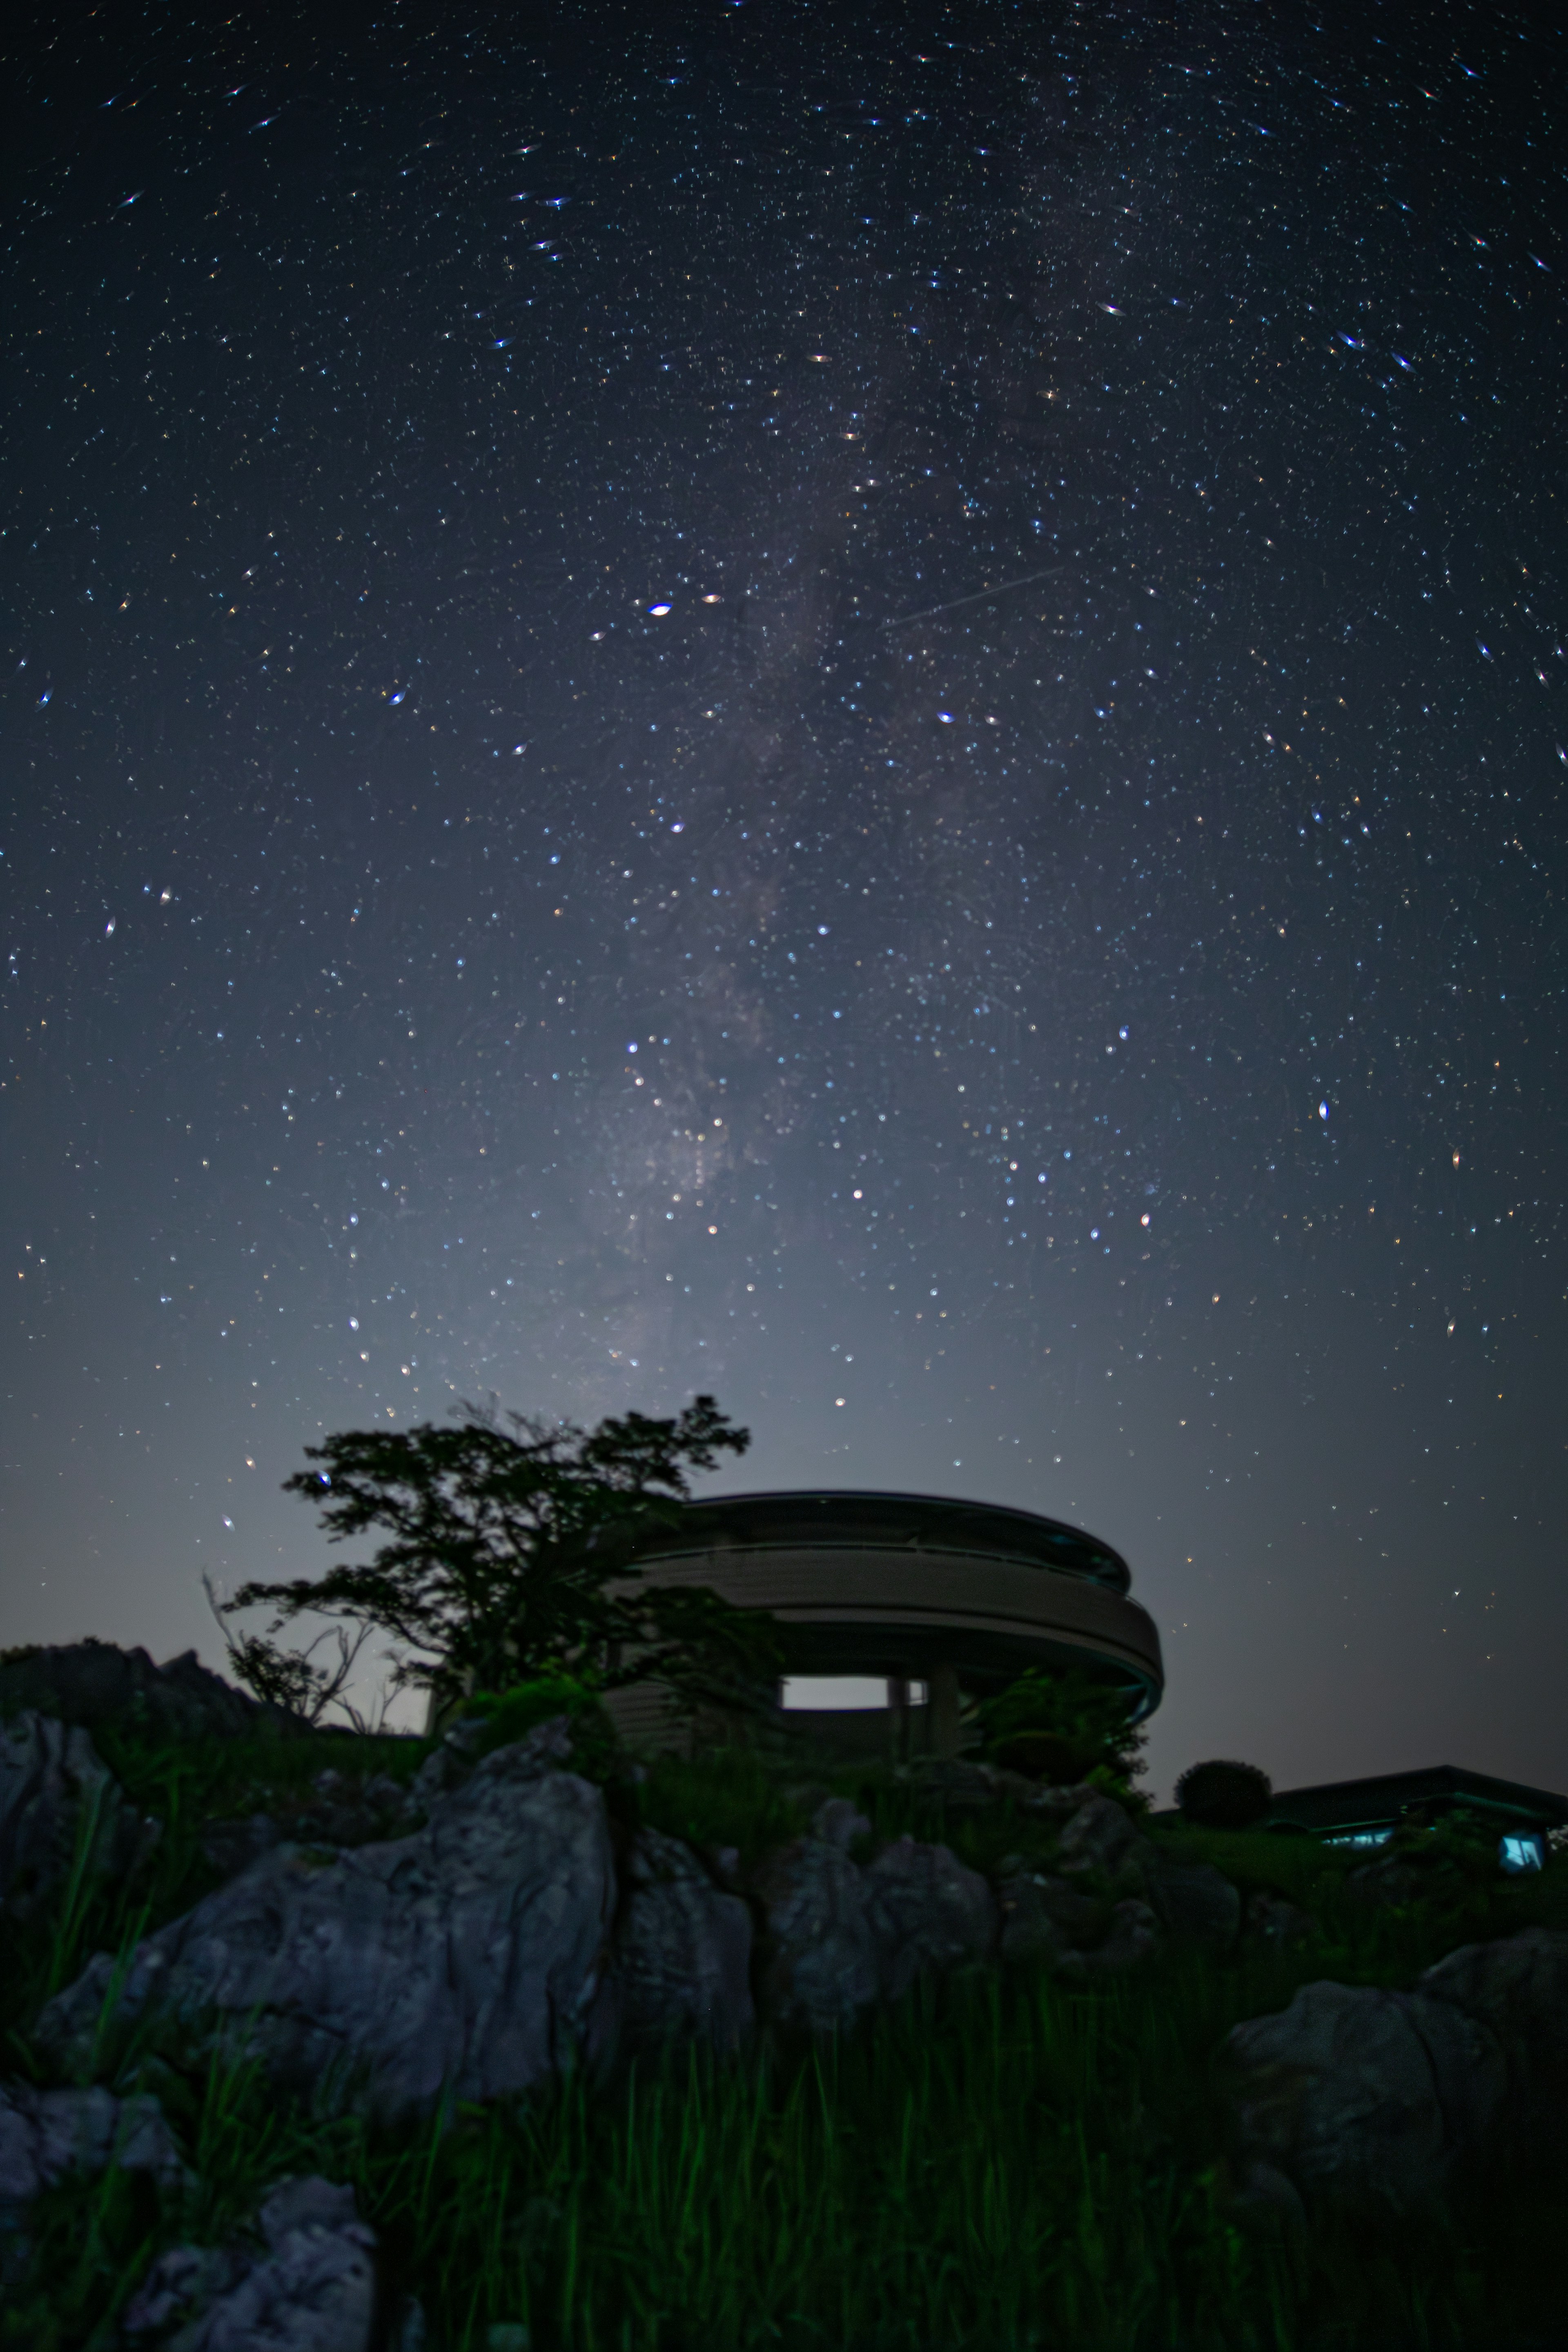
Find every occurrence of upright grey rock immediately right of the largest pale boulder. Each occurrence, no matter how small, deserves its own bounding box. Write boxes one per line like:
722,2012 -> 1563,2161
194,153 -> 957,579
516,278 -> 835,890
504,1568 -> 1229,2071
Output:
588,1830 -> 755,2063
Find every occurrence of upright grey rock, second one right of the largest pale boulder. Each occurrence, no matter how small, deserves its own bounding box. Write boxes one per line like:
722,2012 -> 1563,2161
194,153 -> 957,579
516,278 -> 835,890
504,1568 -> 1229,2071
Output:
752,1837 -> 882,2034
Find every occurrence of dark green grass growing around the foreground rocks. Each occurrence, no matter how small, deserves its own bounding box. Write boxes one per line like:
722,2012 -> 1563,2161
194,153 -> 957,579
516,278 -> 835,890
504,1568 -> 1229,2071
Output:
0,1740 -> 1568,2352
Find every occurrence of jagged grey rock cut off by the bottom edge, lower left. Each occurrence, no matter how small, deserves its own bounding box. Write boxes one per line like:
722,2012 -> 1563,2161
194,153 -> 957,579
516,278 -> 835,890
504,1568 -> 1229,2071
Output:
122,2178 -> 378,2352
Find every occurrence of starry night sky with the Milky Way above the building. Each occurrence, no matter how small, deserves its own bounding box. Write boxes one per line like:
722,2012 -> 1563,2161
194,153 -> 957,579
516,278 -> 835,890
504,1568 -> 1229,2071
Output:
0,0 -> 1568,1792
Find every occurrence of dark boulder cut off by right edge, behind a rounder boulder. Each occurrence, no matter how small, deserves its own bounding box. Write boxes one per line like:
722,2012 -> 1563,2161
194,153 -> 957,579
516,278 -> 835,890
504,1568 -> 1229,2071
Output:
1415,1926 -> 1568,2145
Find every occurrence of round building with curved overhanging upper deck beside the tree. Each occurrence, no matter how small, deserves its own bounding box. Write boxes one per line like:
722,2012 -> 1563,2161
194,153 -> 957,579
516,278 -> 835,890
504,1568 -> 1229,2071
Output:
611,1489 -> 1164,1755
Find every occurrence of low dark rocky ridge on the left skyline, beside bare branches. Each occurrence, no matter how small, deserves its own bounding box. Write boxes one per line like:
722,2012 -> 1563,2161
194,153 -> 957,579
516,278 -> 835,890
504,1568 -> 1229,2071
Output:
0,1642 -> 310,1740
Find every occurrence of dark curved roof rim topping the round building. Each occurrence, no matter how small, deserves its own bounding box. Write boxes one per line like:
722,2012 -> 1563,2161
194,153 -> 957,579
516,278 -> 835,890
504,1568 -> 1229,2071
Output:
637,1486 -> 1133,1592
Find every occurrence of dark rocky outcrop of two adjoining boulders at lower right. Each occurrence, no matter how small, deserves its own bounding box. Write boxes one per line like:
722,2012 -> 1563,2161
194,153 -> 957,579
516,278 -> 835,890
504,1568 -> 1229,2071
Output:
1225,1929 -> 1568,2211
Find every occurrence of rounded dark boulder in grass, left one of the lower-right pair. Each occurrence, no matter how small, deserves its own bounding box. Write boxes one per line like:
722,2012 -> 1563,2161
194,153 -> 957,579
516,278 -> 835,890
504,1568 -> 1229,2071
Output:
1225,1983 -> 1507,2211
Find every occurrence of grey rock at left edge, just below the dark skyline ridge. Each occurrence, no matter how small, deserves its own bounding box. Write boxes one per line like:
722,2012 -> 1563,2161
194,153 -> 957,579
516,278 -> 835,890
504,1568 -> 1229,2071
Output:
0,1710 -> 158,1917
